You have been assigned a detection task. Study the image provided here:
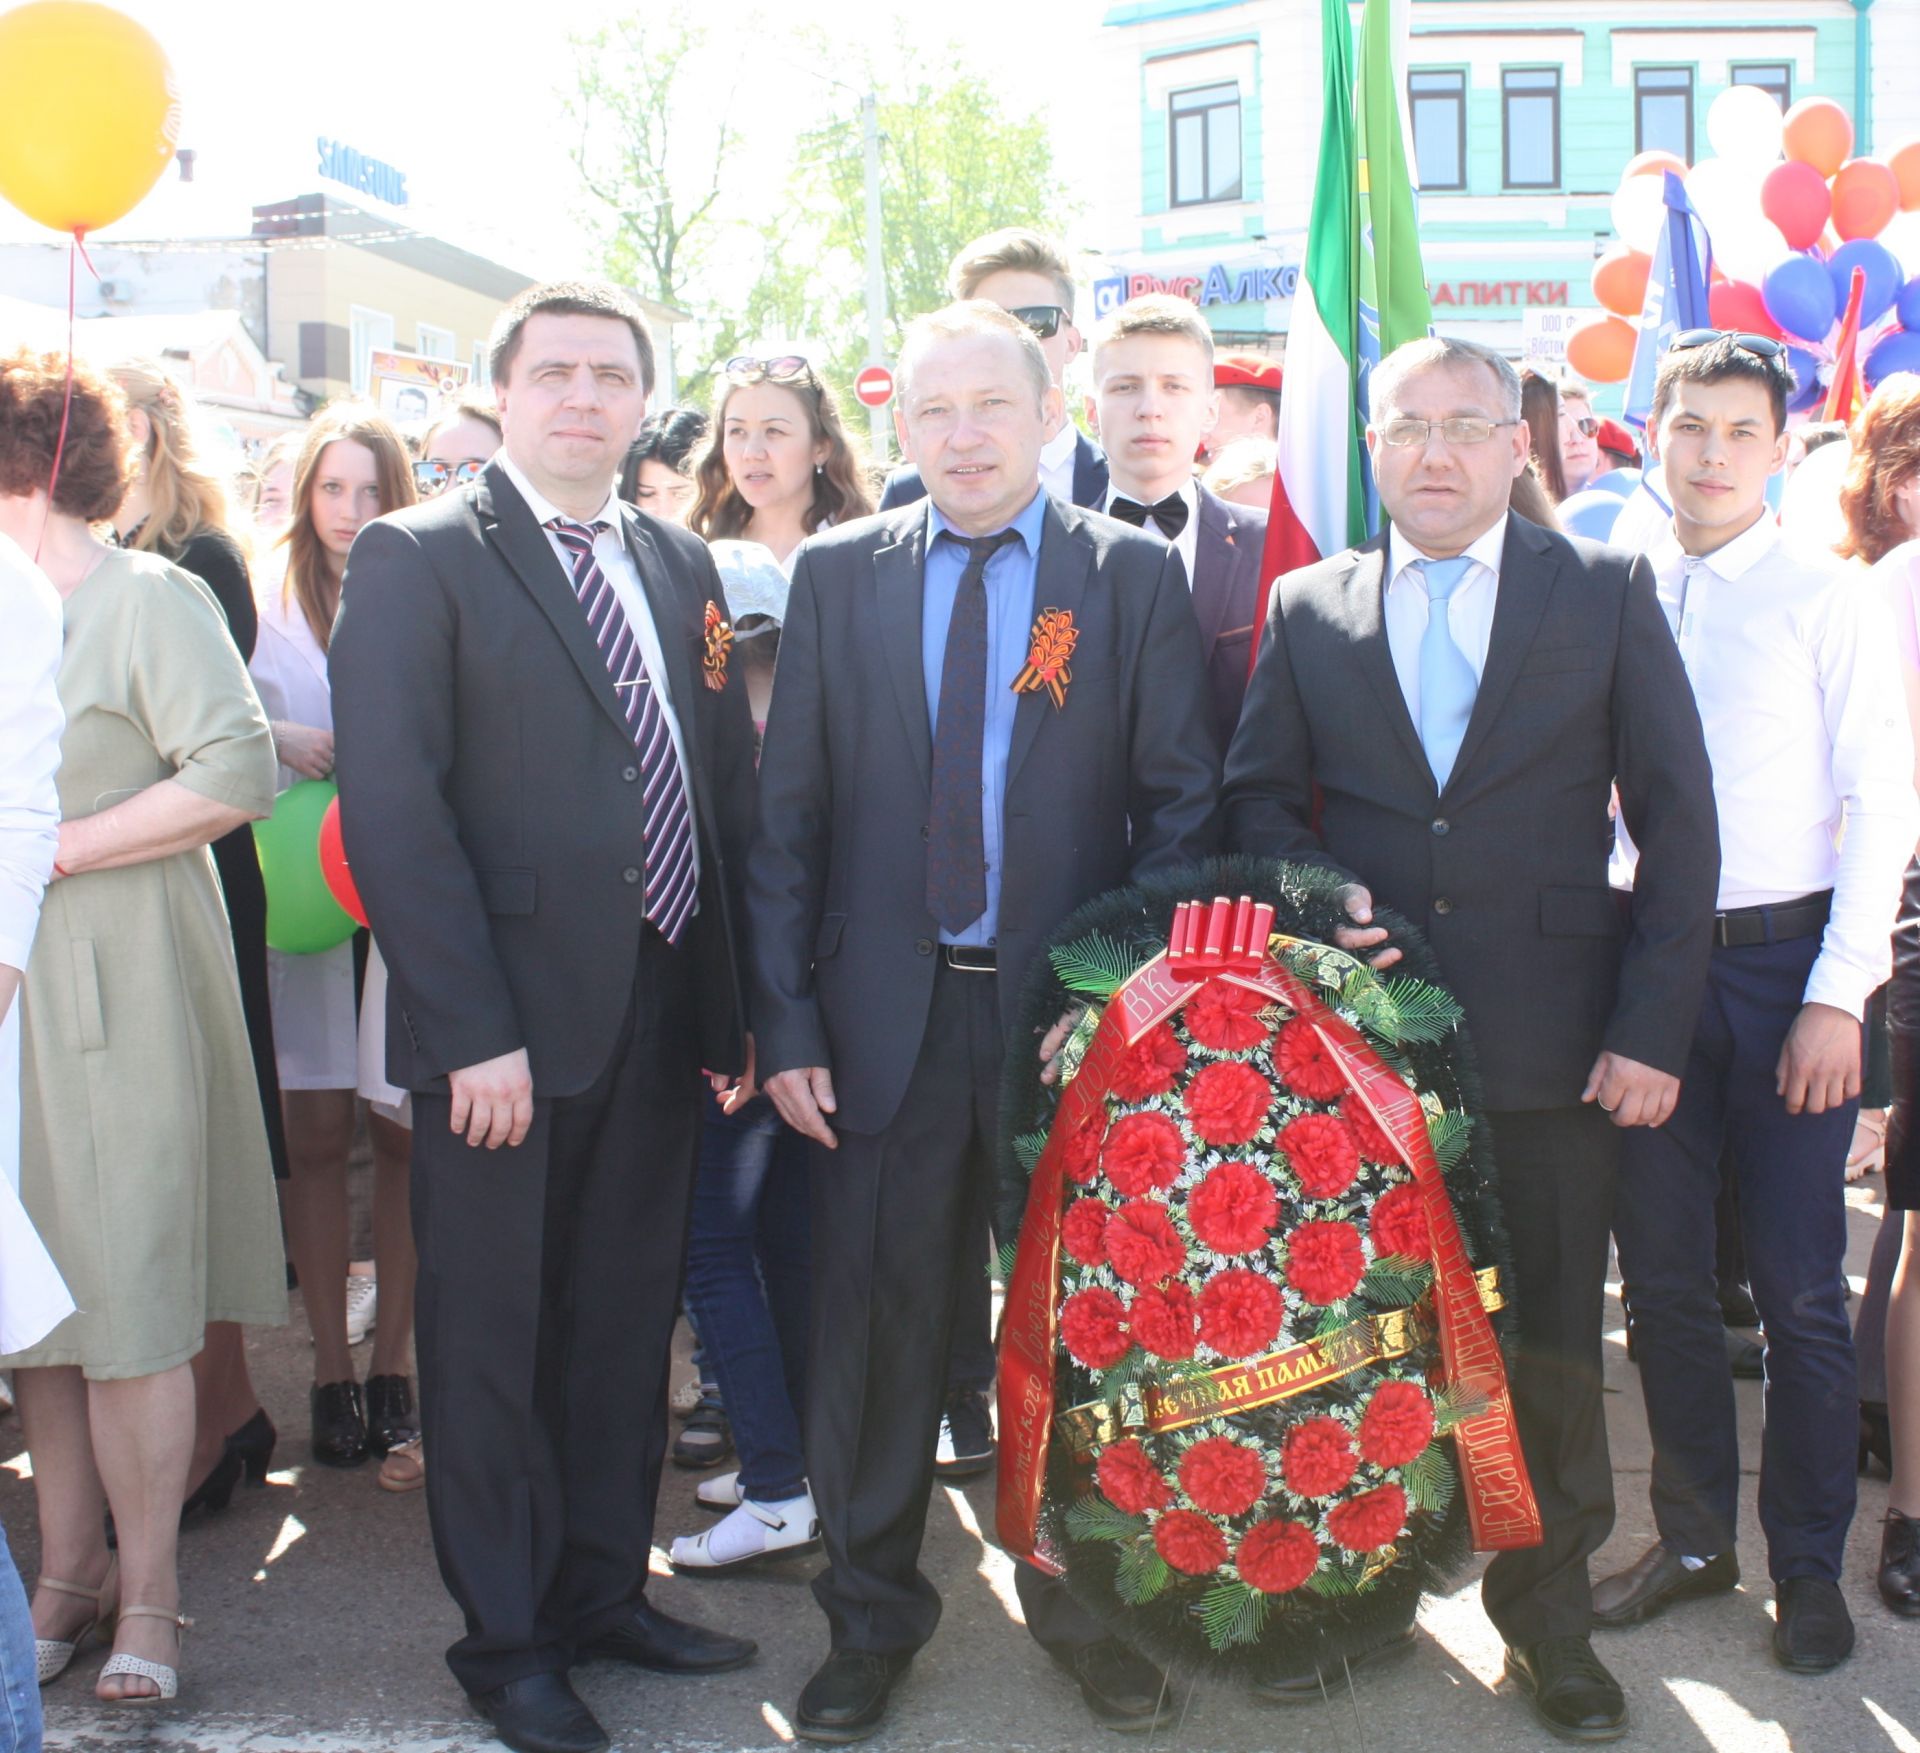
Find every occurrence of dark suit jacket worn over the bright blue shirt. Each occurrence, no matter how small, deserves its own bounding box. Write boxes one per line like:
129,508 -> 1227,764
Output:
747,501 -> 1219,1133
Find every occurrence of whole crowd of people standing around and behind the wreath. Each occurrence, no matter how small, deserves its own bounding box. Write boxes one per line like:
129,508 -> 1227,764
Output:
0,230 -> 1920,1753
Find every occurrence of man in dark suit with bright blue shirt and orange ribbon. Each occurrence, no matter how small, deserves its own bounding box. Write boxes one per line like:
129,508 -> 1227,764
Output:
749,301 -> 1217,1741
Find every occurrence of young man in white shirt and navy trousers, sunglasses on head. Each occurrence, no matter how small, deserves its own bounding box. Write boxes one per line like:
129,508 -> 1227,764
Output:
1594,330 -> 1920,1672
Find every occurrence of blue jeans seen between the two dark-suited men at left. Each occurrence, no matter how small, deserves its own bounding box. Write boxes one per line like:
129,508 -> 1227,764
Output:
687,1096 -> 812,1503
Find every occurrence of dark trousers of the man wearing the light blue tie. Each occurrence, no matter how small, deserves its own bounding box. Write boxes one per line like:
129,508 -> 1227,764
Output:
1480,1106 -> 1620,1644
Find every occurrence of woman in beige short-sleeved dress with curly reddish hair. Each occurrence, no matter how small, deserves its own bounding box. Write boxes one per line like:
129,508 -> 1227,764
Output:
0,351 -> 286,1703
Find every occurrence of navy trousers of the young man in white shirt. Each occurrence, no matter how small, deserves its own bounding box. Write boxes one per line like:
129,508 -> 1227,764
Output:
1613,933 -> 1859,1580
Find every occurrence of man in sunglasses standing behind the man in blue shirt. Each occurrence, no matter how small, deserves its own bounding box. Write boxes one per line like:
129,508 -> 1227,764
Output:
879,225 -> 1106,511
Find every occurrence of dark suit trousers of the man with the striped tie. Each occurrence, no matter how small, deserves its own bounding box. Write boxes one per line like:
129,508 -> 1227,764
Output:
413,925 -> 701,1692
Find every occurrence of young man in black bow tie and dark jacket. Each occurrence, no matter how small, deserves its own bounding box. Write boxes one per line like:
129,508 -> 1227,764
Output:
1087,294 -> 1267,755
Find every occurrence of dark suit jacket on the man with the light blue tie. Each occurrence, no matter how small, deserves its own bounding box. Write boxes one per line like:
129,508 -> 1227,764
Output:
1225,516 -> 1720,1110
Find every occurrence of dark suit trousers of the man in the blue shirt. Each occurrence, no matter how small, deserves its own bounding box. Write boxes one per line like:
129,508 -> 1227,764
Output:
806,964 -> 1106,1651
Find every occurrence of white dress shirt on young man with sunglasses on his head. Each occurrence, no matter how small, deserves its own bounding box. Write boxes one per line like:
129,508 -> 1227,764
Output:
1615,515 -> 1920,1016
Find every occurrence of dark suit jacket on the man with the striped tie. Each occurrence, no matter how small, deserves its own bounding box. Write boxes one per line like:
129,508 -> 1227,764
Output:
328,465 -> 753,1096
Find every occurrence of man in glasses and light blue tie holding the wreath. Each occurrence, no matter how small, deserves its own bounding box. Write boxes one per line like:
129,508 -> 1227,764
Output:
1225,338 -> 1720,1740
